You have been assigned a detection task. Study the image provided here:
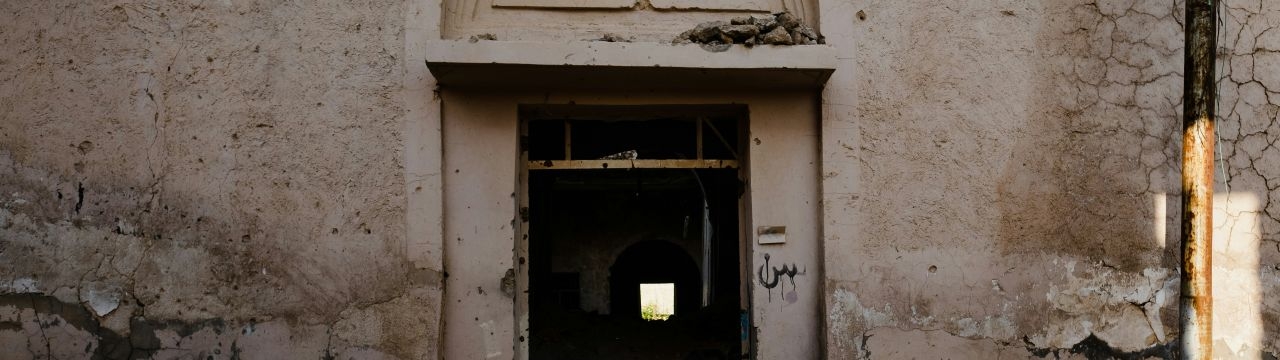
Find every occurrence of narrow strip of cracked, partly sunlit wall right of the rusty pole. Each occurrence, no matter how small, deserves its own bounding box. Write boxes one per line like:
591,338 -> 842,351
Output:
1213,0 -> 1280,359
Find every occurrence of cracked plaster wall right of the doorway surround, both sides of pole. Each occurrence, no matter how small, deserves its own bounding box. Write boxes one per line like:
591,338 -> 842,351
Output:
822,1 -> 1280,359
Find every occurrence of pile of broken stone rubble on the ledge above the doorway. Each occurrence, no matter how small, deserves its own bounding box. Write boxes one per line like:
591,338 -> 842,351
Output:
672,12 -> 826,46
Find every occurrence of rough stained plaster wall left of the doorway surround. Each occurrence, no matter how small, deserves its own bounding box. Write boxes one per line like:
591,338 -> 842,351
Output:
0,0 -> 439,359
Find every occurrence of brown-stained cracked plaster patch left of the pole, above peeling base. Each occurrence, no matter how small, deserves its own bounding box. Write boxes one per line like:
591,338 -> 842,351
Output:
997,1 -> 1181,273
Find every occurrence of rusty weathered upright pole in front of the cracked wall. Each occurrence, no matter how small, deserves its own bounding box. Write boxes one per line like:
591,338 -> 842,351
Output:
1179,0 -> 1217,360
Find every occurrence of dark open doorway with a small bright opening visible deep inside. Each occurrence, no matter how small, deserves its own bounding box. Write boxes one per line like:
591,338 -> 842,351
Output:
520,106 -> 750,360
